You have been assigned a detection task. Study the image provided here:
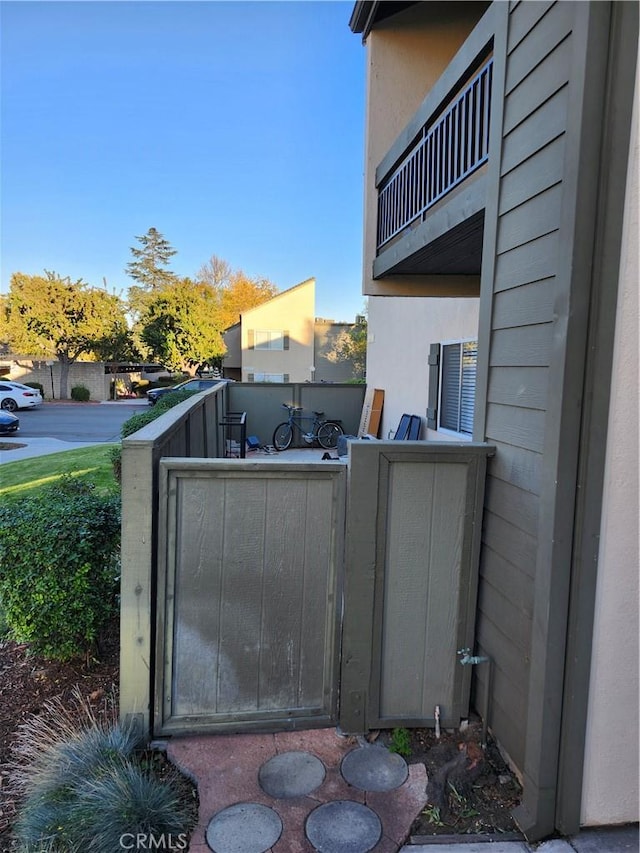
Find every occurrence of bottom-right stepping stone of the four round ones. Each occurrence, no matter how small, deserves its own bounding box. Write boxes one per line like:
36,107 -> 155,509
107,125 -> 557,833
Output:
305,800 -> 382,853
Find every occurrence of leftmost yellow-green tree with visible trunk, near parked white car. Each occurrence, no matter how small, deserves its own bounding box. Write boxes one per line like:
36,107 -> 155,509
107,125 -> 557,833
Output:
6,270 -> 125,399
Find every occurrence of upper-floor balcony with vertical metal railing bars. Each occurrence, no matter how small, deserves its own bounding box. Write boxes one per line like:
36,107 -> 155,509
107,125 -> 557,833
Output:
373,9 -> 494,279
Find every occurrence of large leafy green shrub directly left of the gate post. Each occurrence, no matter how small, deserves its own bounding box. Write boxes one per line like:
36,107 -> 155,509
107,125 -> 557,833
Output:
0,476 -> 120,660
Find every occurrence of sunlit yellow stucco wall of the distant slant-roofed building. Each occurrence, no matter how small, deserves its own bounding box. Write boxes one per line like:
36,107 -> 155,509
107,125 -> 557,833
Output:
242,279 -> 315,382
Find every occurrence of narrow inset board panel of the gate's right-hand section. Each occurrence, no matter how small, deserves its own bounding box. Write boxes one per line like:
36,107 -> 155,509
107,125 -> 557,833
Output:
379,462 -> 467,719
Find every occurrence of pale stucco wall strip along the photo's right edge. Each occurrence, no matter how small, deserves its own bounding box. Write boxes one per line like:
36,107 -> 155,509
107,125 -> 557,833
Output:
582,51 -> 640,826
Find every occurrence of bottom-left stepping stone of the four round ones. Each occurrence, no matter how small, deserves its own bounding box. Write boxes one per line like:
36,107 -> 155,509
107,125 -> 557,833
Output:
207,803 -> 282,853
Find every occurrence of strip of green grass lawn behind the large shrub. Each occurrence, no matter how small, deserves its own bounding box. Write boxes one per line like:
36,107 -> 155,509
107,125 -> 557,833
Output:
0,444 -> 119,500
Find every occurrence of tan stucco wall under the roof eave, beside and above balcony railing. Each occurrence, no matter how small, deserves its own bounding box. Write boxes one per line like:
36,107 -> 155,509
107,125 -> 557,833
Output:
363,2 -> 487,295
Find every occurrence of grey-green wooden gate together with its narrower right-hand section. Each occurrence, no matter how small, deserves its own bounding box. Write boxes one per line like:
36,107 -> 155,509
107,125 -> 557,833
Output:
152,442 -> 492,735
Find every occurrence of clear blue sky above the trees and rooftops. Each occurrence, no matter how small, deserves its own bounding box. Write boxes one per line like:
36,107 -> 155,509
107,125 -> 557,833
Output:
0,0 -> 365,320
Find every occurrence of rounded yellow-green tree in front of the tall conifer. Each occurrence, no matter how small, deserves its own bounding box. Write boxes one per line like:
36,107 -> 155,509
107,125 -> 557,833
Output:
140,278 -> 225,370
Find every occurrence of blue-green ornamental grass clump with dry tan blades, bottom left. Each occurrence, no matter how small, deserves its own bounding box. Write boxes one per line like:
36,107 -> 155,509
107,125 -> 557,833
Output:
11,694 -> 193,853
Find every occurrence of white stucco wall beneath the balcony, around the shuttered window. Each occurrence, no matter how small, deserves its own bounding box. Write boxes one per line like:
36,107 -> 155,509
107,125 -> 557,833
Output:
367,296 -> 479,440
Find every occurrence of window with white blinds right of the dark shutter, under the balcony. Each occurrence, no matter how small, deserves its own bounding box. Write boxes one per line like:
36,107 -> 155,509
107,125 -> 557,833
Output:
439,341 -> 478,435
